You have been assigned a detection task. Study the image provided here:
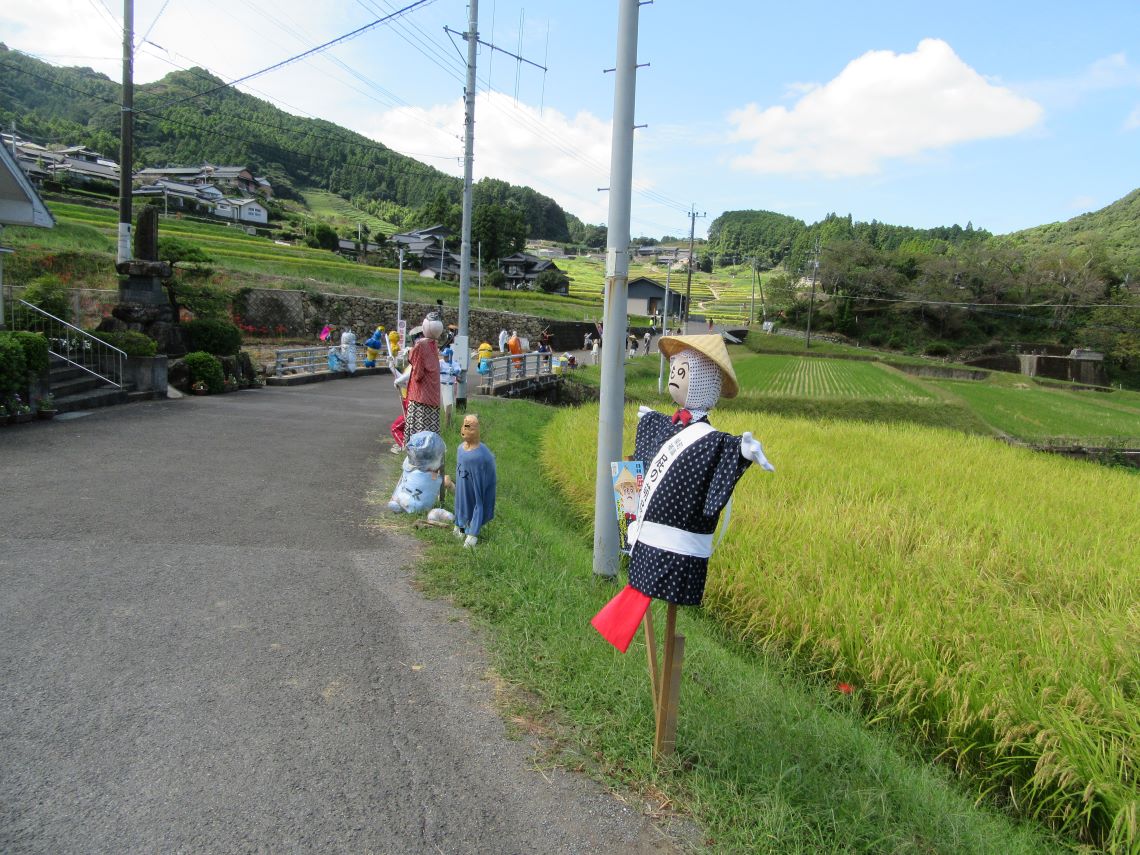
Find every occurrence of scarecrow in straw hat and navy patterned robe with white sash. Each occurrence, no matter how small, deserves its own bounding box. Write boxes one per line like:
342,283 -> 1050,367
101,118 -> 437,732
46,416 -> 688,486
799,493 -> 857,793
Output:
592,335 -> 774,755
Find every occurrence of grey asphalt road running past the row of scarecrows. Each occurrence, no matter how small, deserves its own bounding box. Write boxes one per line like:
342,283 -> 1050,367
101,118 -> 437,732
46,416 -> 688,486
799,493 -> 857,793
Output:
0,376 -> 673,855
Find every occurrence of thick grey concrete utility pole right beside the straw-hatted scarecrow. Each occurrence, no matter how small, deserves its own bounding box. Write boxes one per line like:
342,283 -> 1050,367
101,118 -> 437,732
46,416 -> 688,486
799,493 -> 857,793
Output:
594,0 -> 640,577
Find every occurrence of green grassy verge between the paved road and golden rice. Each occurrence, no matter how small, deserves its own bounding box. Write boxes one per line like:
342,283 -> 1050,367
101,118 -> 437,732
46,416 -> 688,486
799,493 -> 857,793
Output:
385,401 -> 1060,853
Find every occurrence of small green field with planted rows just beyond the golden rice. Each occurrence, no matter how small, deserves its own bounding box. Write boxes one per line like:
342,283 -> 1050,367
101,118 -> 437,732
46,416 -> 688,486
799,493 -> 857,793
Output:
738,356 -> 936,400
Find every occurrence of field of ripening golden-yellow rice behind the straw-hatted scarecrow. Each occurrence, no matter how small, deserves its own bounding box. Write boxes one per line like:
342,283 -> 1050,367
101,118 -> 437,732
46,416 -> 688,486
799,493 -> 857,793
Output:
544,407 -> 1140,852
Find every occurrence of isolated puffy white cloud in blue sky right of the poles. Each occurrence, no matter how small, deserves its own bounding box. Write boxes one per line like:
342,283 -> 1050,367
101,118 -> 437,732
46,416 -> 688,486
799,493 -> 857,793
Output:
728,39 -> 1043,177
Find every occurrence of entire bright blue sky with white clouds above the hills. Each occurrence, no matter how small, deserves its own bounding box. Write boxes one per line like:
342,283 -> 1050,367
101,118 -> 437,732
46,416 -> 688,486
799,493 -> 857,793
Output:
0,0 -> 1140,237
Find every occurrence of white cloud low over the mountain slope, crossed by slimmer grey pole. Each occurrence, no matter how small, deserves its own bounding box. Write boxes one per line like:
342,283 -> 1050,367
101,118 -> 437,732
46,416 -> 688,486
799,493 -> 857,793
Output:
358,92 -> 610,222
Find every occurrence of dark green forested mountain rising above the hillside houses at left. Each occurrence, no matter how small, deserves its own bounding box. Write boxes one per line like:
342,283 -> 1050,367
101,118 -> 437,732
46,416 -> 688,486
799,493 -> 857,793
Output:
0,46 -> 570,241
